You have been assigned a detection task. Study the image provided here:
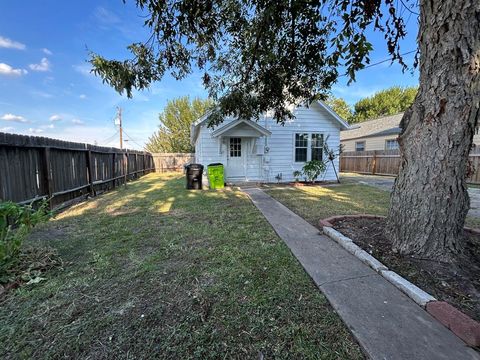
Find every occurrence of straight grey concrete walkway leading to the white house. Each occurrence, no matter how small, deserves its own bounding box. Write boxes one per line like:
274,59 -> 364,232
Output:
243,188 -> 480,360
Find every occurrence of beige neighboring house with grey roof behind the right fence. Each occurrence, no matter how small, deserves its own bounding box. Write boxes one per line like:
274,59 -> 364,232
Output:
340,113 -> 403,151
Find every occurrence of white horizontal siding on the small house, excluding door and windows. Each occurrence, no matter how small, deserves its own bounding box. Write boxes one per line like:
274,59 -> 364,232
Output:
195,103 -> 340,182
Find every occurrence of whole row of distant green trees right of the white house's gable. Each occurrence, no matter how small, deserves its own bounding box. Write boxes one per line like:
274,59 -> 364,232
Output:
326,86 -> 418,124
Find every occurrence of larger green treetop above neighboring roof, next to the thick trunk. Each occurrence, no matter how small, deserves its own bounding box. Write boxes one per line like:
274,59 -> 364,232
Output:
351,86 -> 418,122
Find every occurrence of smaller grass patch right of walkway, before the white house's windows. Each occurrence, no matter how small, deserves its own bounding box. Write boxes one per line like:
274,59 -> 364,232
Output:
264,181 -> 480,228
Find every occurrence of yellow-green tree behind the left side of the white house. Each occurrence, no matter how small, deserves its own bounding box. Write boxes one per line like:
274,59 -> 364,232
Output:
146,96 -> 212,153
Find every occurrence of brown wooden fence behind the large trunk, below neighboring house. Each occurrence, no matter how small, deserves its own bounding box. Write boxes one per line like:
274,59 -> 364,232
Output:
340,147 -> 480,184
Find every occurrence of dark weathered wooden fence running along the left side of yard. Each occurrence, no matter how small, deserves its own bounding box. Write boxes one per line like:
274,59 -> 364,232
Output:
0,133 -> 154,207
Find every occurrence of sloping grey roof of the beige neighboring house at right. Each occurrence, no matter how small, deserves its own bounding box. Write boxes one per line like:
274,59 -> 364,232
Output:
340,113 -> 403,141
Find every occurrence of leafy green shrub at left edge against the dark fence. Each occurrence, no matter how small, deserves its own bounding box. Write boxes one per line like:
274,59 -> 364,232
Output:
0,201 -> 50,283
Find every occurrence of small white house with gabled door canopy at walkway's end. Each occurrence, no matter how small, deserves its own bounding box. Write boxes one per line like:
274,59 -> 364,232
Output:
191,101 -> 348,182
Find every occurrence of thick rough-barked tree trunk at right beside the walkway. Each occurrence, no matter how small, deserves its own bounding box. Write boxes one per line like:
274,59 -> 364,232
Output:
387,0 -> 480,261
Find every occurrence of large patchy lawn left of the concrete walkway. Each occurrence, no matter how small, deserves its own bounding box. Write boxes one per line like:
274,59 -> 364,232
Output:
0,174 -> 363,359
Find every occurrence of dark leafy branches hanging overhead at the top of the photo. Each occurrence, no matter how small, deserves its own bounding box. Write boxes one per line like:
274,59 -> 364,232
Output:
90,0 -> 414,125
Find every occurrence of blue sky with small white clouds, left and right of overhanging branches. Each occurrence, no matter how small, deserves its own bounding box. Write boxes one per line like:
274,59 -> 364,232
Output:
0,0 -> 418,149
